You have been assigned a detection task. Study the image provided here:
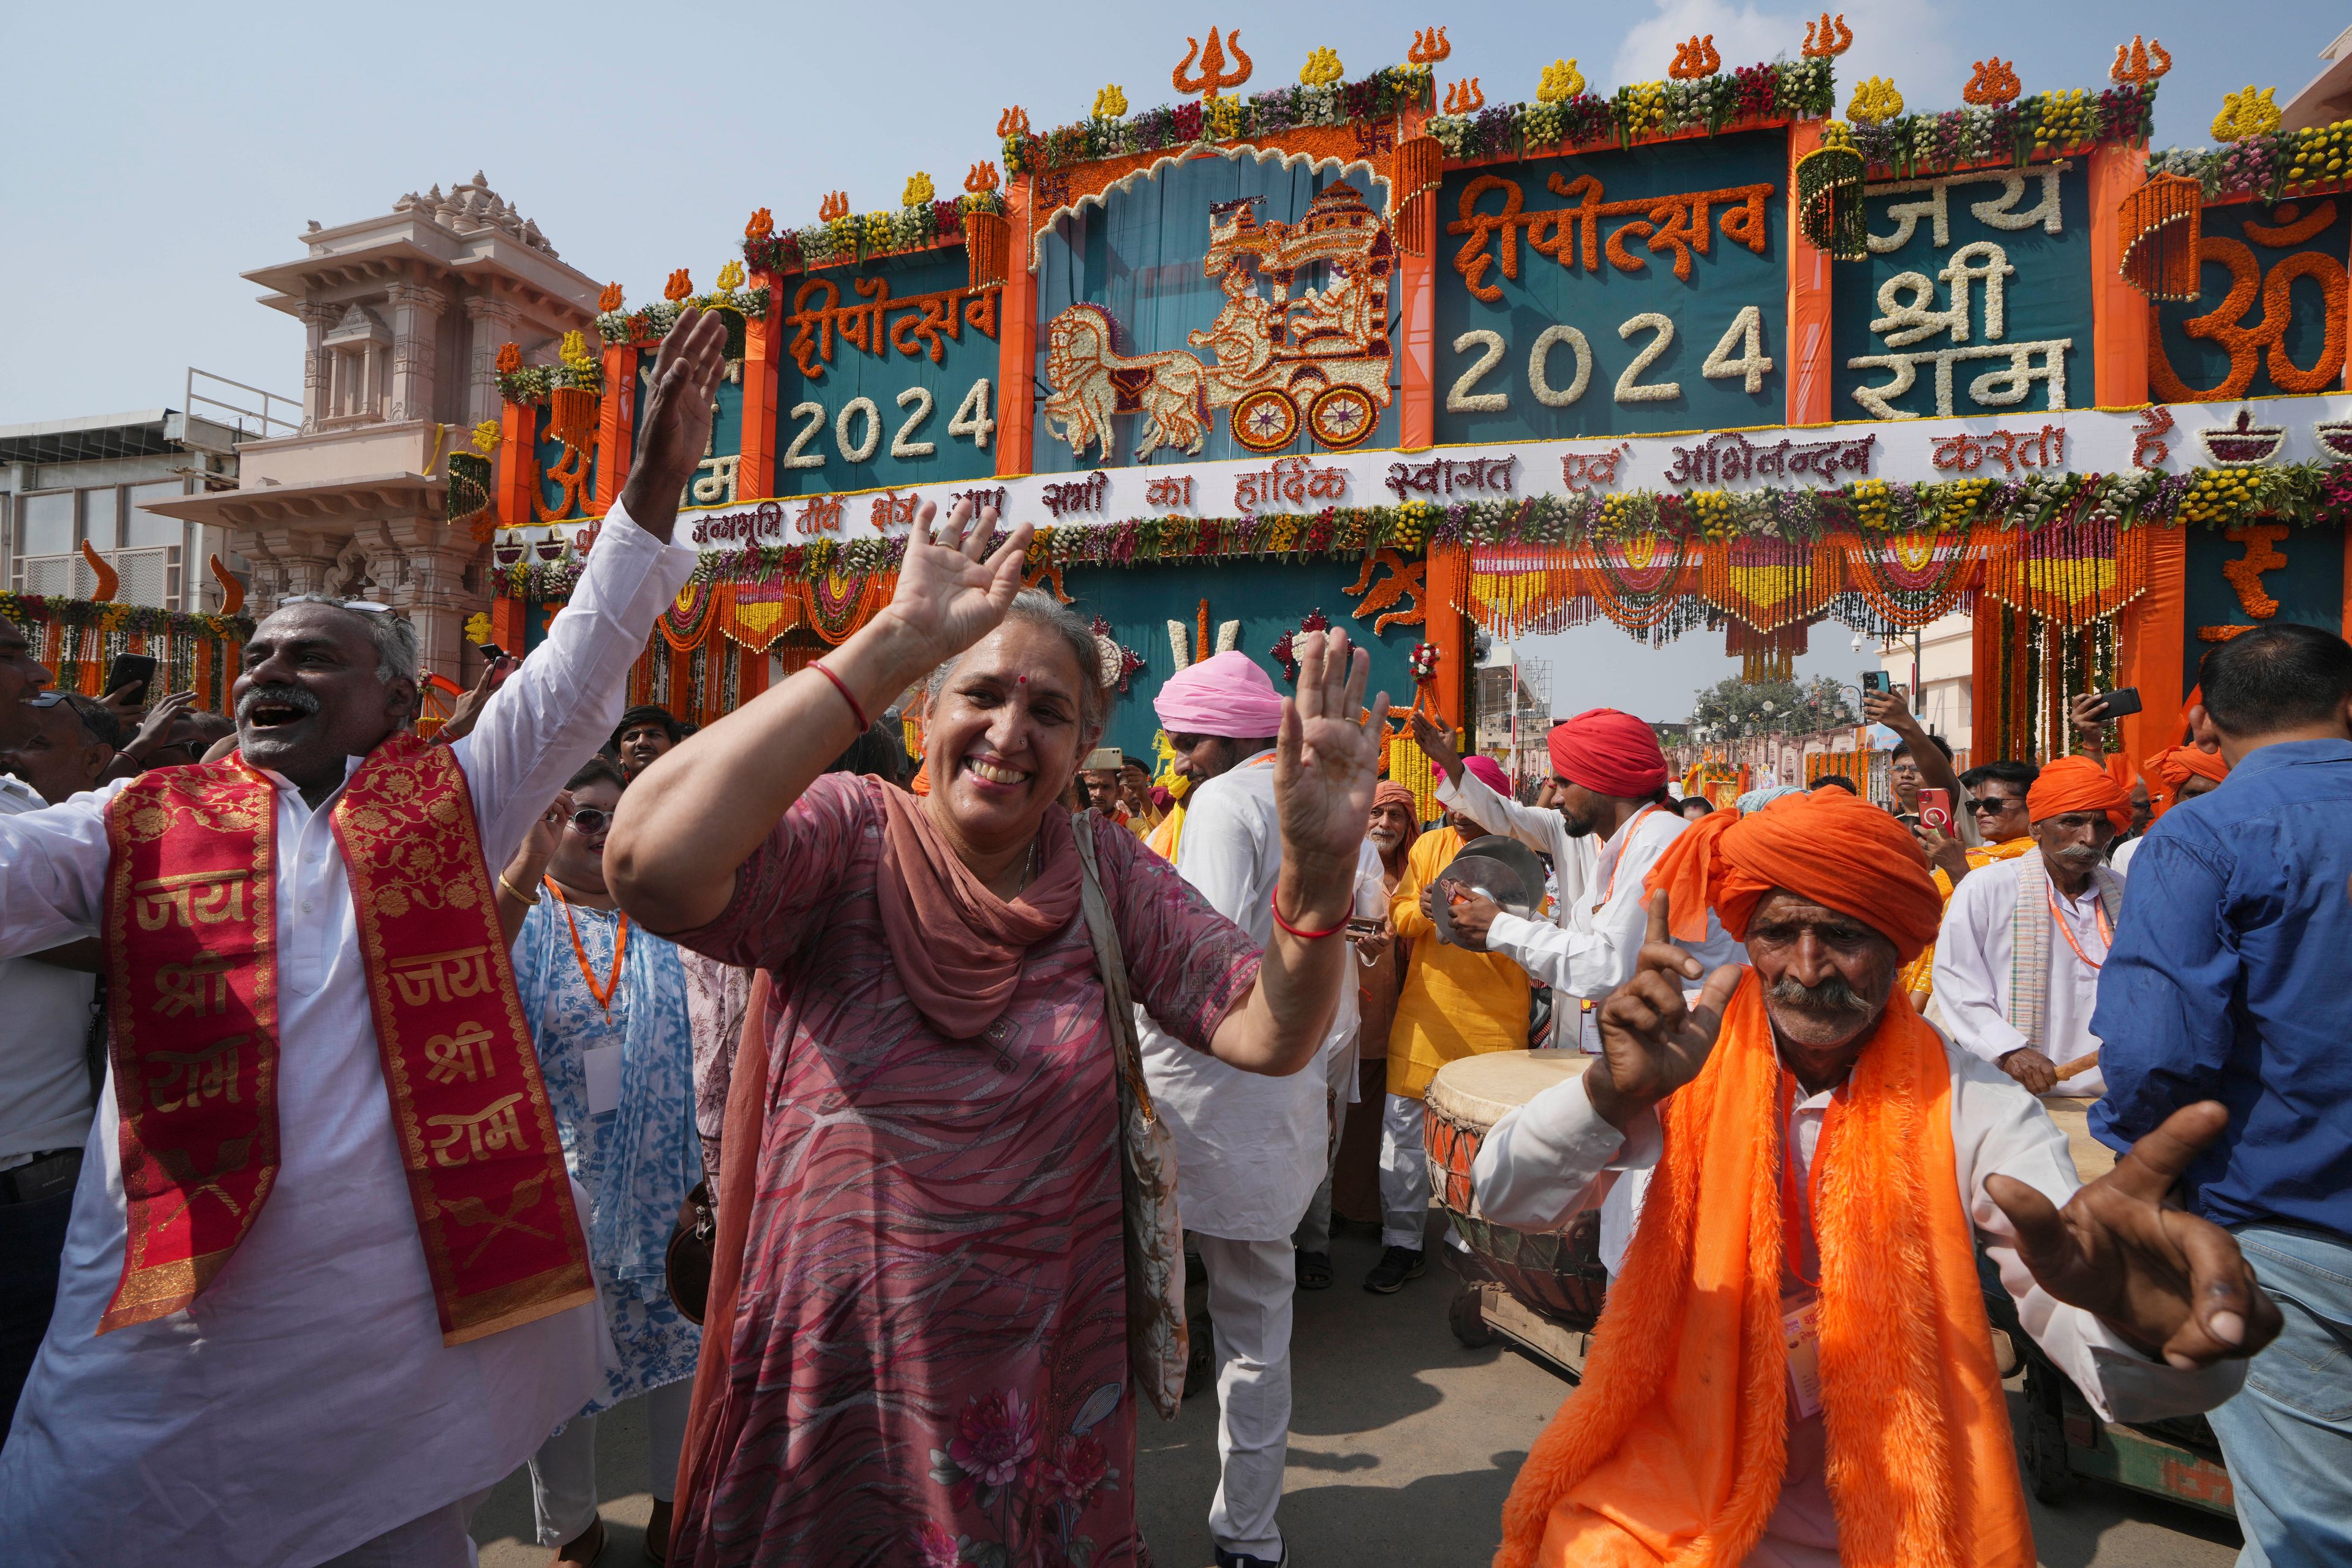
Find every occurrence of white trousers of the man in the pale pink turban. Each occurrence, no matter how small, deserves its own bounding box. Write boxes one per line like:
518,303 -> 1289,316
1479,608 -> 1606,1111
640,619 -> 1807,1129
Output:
1193,1234 -> 1298,1563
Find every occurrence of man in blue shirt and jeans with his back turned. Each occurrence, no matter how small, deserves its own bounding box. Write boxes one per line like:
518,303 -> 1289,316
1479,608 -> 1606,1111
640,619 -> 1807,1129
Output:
2091,625 -> 2352,1568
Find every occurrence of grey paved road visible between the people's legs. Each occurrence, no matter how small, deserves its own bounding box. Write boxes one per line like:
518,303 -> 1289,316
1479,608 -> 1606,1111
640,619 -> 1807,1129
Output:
475,1237 -> 2237,1568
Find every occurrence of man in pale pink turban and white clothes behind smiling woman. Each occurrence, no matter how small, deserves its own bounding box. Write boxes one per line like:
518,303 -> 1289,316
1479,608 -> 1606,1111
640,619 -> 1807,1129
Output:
1140,651 -> 1381,1568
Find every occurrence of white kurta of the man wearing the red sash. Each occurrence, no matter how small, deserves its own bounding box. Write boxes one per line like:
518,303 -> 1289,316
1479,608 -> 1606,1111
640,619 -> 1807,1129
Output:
0,505 -> 696,1568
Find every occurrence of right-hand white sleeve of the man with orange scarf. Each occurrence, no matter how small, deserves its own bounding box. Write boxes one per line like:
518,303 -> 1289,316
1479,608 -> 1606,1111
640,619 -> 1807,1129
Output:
1952,1058 -> 2246,1422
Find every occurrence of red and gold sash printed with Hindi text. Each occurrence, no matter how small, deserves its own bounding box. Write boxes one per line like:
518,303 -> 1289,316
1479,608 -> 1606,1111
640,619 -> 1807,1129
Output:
99,736 -> 595,1344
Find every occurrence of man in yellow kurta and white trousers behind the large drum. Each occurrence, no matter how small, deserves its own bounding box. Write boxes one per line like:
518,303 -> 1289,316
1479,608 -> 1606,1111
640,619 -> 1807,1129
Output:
1364,757 -> 1526,1295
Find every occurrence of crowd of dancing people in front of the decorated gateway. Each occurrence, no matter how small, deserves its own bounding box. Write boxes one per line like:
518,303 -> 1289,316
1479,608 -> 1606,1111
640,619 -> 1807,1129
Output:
0,311 -> 2352,1568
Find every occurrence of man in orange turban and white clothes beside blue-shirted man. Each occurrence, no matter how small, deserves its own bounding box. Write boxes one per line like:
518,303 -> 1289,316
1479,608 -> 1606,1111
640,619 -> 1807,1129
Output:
1936,757 -> 2131,1100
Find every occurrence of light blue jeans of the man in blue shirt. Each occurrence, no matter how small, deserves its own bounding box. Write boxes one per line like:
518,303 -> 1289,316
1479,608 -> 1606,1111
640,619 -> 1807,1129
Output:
2209,1225 -> 2352,1568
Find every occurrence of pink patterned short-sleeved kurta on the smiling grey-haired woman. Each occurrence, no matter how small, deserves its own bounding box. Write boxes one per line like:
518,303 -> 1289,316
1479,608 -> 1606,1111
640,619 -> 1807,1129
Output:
675,774 -> 1258,1568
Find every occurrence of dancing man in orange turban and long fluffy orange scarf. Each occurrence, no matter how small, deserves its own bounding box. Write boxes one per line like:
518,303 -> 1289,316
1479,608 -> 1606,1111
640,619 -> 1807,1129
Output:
1475,792 -> 2279,1568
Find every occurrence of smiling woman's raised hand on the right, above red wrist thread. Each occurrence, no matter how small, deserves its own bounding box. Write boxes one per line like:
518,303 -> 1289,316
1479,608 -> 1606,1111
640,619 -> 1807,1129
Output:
1275,630 -> 1388,917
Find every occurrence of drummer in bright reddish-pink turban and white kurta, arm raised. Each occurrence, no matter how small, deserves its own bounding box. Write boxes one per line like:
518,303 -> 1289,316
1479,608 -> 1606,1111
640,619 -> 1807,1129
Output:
1414,707 -> 1741,1051
